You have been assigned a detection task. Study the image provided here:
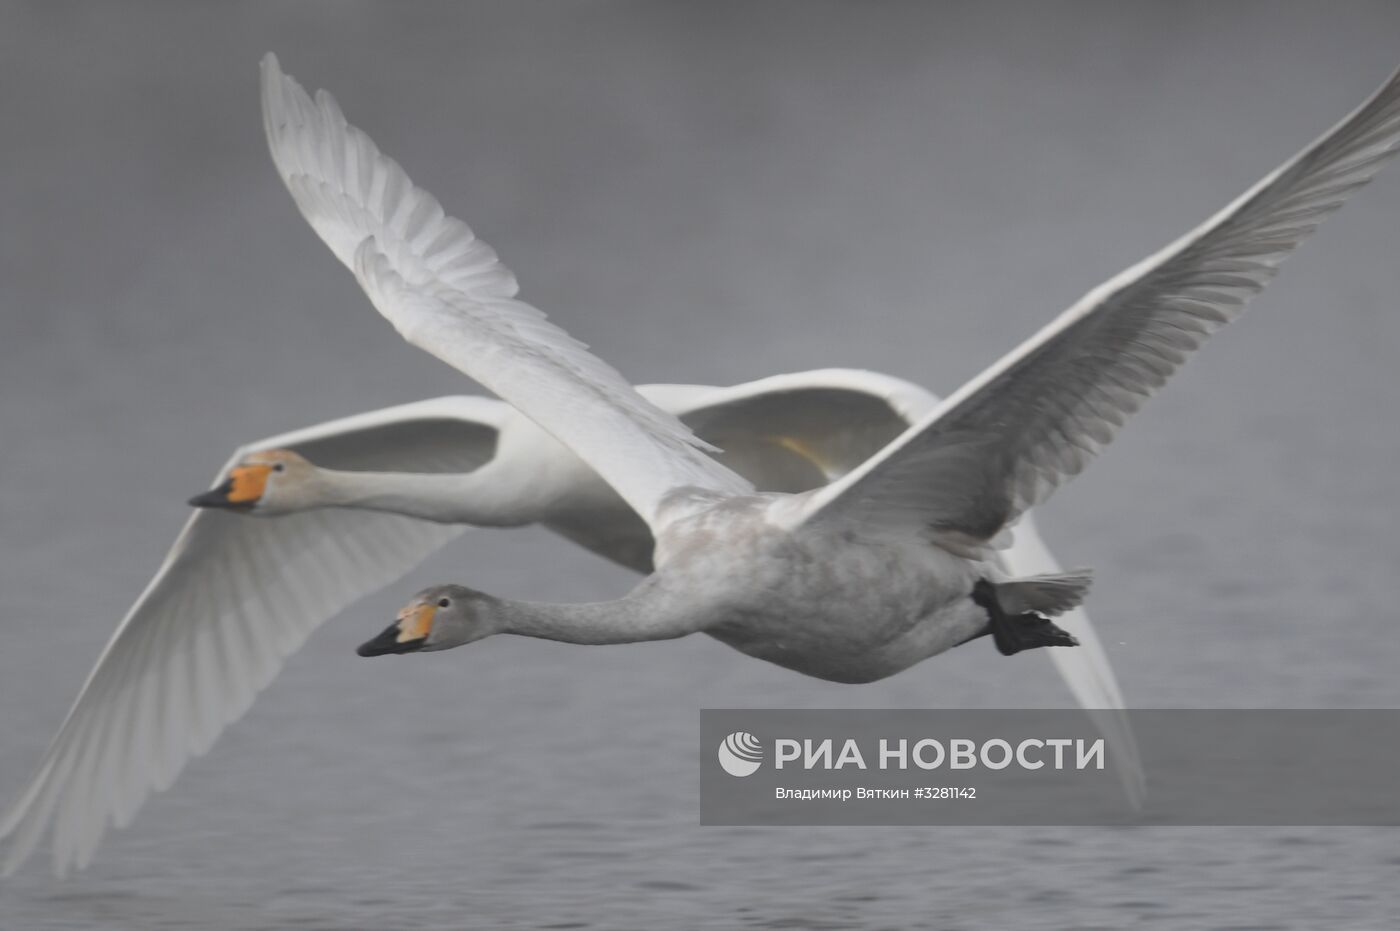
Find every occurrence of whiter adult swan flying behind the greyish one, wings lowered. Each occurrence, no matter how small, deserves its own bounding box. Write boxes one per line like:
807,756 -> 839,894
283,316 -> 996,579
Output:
0,370 -> 1142,874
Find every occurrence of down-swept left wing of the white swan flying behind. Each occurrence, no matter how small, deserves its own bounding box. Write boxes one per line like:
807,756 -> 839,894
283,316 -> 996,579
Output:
0,398 -> 508,875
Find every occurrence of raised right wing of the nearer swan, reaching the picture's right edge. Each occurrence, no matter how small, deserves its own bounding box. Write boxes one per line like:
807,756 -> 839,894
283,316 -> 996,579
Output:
799,65 -> 1400,540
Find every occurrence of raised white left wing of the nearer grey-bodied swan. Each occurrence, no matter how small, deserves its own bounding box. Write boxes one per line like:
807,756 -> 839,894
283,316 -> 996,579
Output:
262,55 -> 750,522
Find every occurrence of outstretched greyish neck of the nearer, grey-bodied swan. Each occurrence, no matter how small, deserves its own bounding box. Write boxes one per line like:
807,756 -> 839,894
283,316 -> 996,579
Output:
493,575 -> 704,644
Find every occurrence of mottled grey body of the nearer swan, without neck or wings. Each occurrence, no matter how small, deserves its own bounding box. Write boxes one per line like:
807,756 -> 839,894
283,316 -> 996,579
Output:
652,494 -> 1007,683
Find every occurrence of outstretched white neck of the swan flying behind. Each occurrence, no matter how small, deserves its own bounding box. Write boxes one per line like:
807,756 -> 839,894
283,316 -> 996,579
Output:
316,462 -> 540,526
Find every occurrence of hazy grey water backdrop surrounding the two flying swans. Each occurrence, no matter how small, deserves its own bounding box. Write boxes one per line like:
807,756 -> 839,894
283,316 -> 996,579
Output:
0,3 -> 1400,931
